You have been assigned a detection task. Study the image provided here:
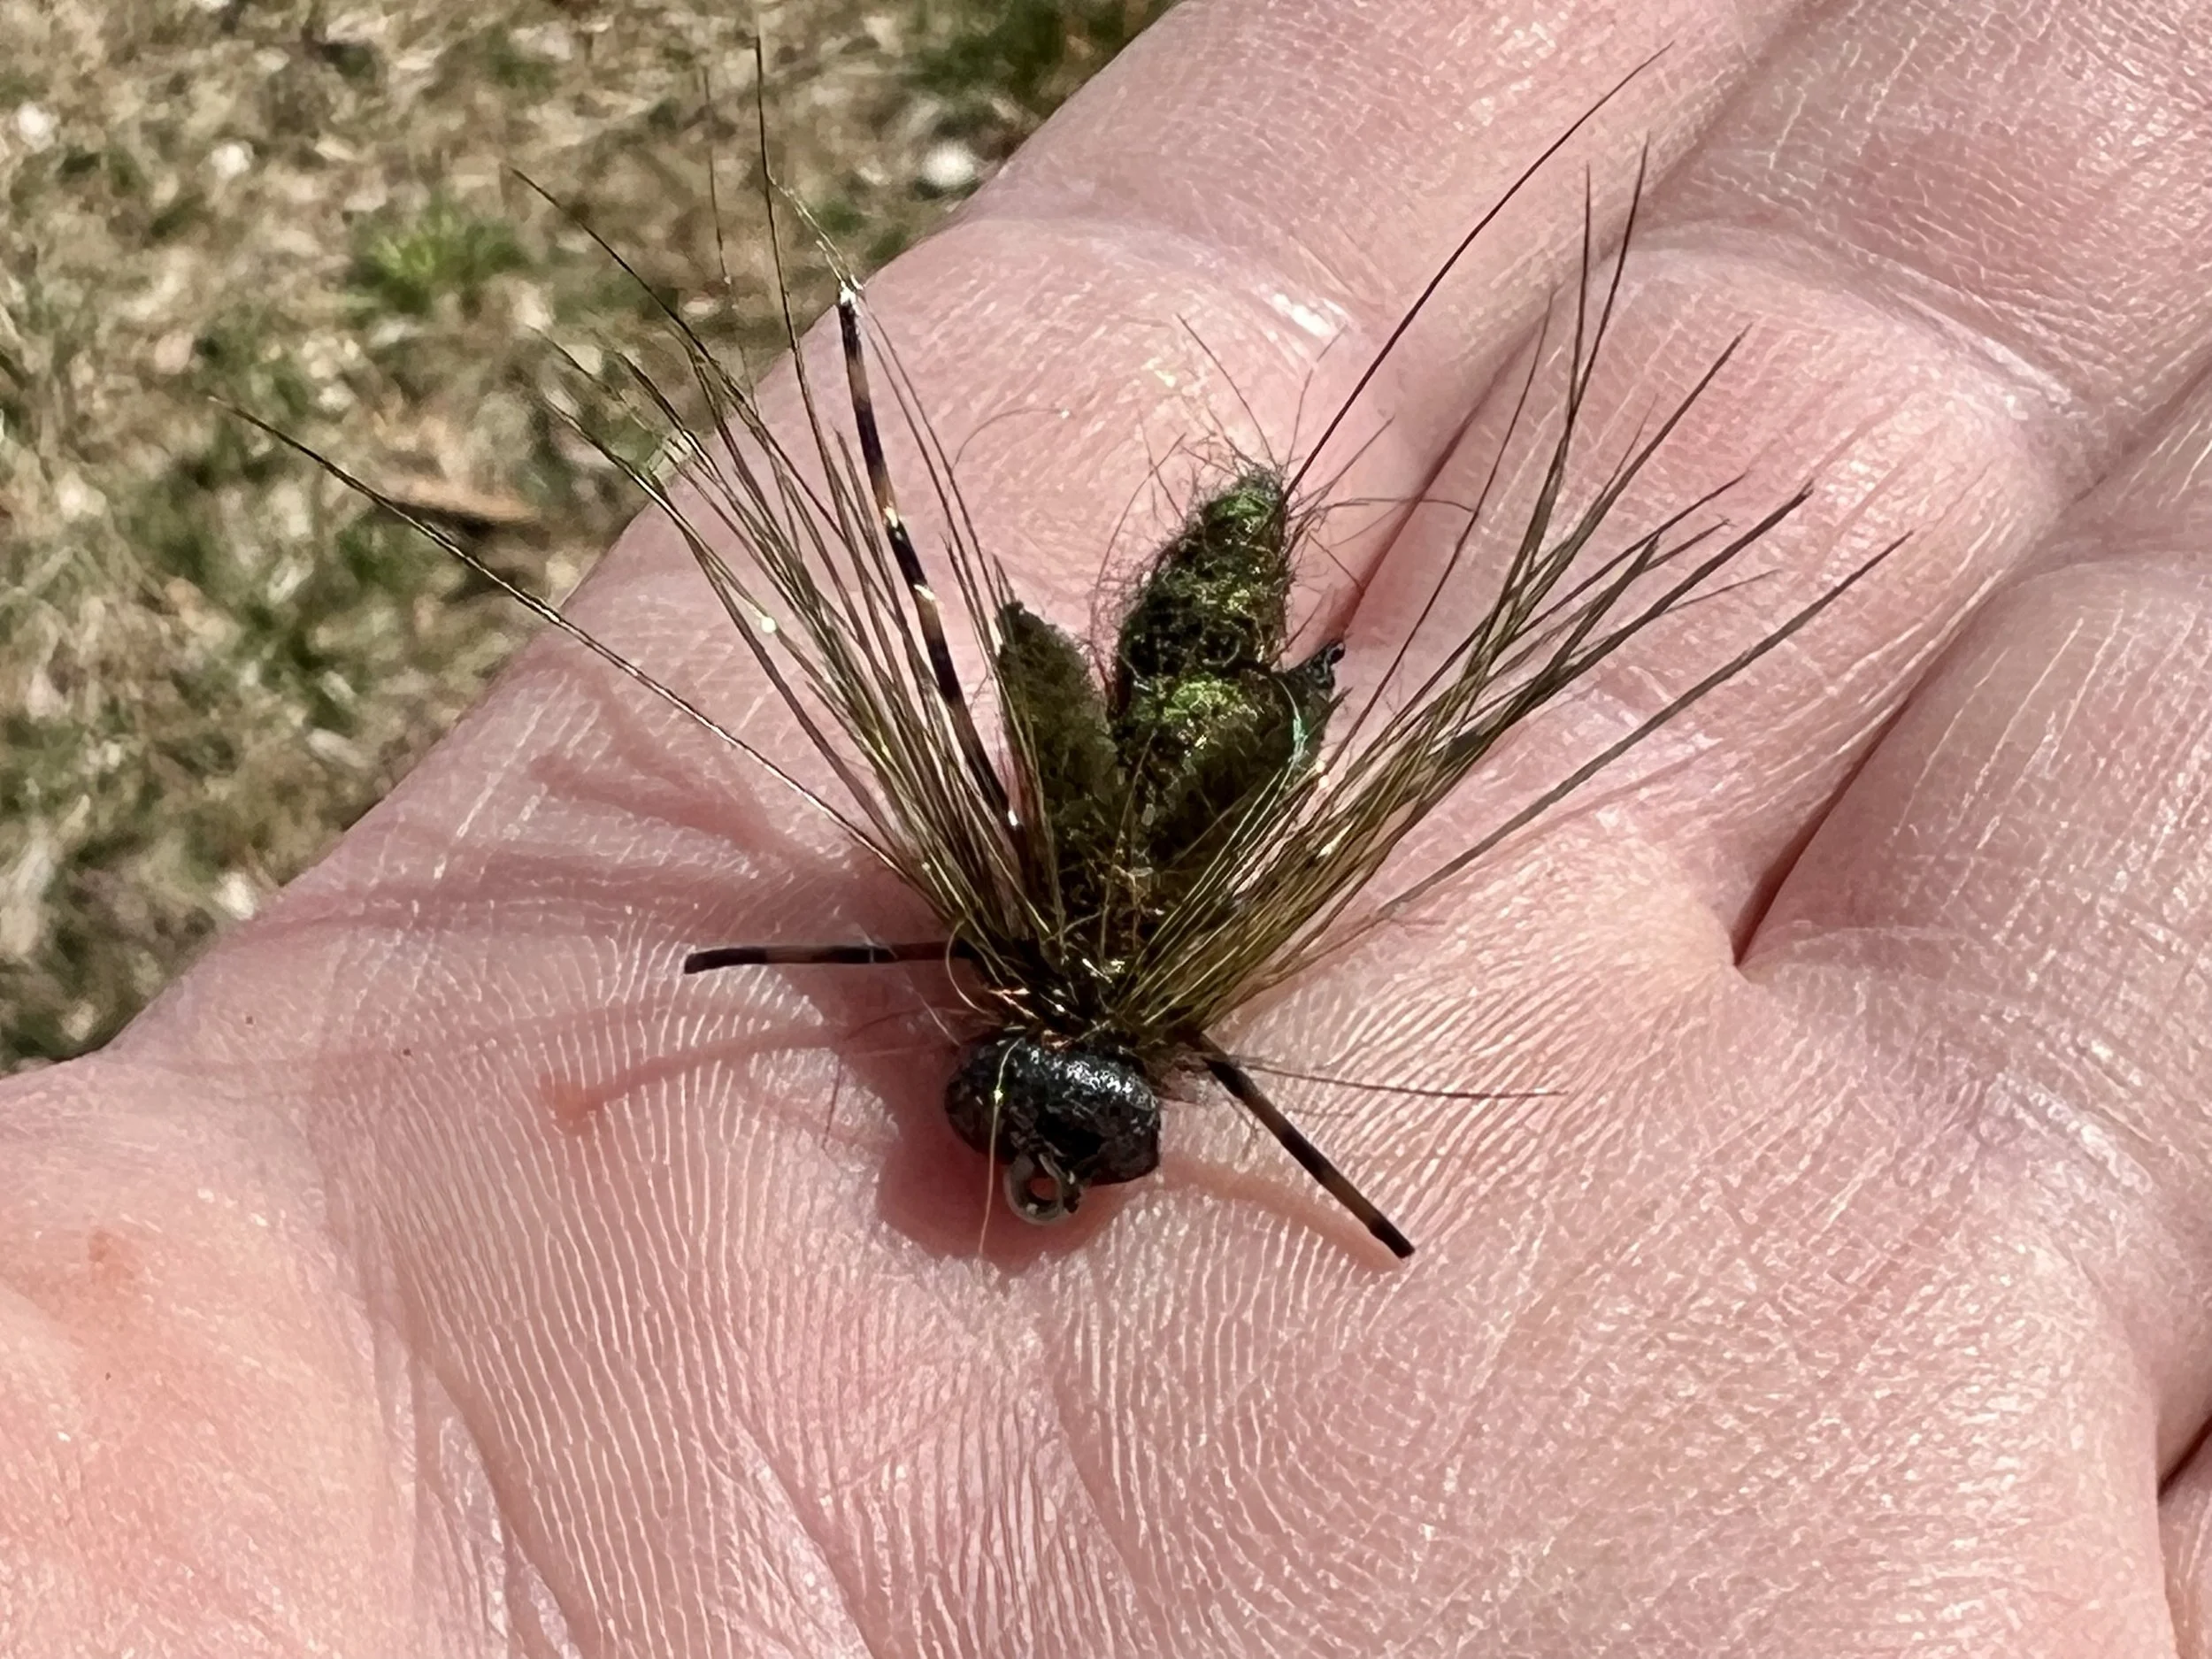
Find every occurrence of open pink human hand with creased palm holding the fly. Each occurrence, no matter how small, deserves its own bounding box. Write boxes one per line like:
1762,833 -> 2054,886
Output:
0,0 -> 2212,1659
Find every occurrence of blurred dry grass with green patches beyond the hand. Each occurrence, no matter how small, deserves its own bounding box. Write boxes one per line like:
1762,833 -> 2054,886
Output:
0,0 -> 1171,1071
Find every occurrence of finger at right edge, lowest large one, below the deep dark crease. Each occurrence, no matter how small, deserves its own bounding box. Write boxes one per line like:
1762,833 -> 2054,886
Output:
1746,373 -> 2212,1653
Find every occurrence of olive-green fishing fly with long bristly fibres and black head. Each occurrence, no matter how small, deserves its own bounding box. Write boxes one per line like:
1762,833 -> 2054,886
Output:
257,58 -> 1883,1256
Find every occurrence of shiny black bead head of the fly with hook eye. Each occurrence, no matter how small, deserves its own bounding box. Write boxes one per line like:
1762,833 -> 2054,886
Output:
945,1031 -> 1159,1224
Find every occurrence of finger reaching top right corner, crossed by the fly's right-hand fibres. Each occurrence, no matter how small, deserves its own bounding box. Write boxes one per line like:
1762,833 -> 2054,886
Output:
1336,3 -> 2212,927
